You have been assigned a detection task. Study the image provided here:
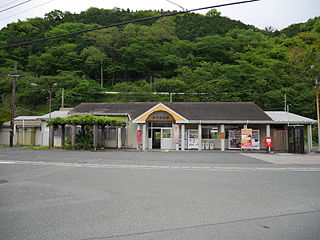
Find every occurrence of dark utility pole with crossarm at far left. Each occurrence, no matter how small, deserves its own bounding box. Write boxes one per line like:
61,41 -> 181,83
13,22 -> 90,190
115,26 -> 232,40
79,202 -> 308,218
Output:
8,62 -> 20,147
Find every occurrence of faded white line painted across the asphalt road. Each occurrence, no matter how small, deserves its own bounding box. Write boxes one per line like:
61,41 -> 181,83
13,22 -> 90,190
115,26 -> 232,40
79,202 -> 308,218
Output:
0,160 -> 320,172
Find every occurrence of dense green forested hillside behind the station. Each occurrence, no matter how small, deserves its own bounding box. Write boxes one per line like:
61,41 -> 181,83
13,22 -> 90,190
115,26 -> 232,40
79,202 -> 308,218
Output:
0,8 -> 320,118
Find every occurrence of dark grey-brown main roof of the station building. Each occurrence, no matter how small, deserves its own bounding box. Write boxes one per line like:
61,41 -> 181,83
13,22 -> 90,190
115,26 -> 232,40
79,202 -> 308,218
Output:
69,102 -> 272,121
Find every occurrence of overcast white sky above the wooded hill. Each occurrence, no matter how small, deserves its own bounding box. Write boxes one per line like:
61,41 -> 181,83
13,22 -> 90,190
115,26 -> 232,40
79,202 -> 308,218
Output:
0,0 -> 320,30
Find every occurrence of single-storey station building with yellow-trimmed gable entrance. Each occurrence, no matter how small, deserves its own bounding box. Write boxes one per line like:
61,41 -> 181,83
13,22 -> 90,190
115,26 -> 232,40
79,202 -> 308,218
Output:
68,102 -> 316,153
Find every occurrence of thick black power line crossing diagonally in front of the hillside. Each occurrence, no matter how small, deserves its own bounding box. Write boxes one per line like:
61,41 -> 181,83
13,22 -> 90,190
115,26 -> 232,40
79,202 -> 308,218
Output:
0,0 -> 260,49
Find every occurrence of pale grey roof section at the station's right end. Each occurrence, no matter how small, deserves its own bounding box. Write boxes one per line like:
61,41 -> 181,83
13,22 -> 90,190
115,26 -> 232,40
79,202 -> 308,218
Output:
265,111 -> 317,124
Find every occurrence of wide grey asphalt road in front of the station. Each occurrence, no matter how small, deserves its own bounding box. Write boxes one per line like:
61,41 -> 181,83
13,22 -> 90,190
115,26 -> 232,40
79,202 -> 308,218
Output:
0,149 -> 320,240
